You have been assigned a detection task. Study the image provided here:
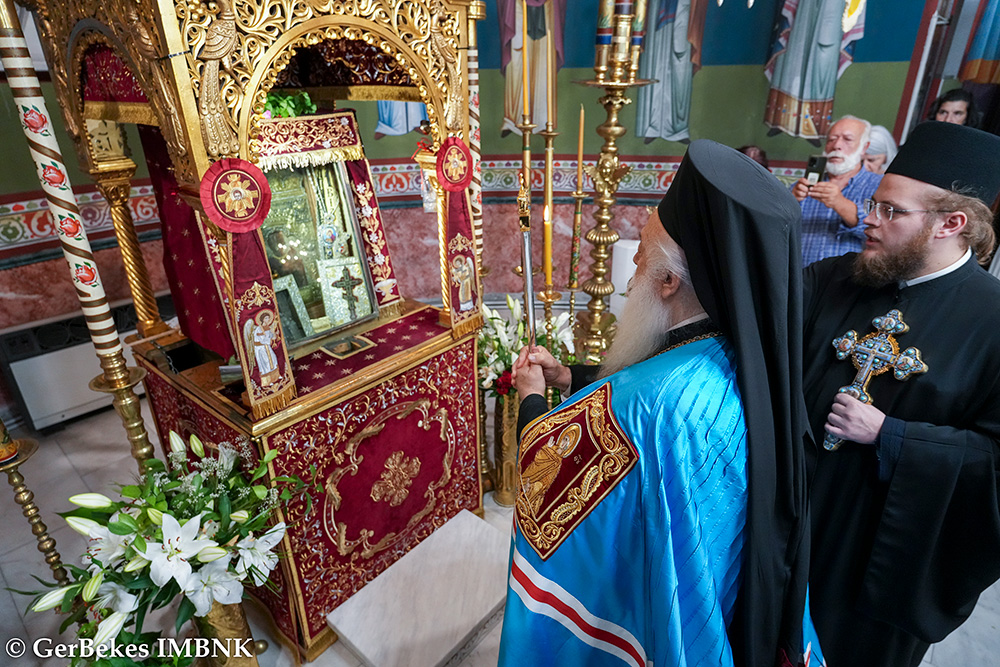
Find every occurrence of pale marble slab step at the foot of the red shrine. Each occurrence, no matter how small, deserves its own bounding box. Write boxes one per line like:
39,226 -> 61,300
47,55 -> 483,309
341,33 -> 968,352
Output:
327,510 -> 509,667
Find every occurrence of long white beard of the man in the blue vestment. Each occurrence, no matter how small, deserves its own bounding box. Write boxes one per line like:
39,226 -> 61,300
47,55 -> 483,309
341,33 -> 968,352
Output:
599,276 -> 674,378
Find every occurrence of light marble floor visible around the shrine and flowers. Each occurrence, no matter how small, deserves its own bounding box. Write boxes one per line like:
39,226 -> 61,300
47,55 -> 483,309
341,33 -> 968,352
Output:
0,406 -> 1000,667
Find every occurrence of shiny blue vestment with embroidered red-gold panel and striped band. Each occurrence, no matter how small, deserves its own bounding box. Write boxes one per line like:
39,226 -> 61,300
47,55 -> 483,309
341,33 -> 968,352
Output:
499,335 -> 822,667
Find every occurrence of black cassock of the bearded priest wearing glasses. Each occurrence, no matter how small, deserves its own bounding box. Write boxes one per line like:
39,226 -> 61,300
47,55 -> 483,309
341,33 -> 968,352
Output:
803,124 -> 1000,667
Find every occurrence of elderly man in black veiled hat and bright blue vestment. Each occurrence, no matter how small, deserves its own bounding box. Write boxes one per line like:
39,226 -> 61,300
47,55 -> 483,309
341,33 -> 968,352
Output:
500,140 -> 822,667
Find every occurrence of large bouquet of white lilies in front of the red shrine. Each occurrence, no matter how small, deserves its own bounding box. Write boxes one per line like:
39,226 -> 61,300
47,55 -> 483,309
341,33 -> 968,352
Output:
31,431 -> 315,666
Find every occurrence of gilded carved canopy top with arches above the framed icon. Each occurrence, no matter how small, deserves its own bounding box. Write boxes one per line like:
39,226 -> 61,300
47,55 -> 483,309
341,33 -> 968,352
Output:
35,0 -> 483,190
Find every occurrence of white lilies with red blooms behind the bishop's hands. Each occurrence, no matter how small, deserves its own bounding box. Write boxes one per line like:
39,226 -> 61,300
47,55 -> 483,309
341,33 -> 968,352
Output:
479,294 -> 573,396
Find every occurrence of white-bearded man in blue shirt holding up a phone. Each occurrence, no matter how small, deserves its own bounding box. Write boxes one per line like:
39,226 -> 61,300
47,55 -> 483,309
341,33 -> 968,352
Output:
792,116 -> 882,266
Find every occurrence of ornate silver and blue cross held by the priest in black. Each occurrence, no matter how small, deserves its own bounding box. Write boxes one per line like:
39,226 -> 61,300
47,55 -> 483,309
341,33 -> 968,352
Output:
823,310 -> 927,451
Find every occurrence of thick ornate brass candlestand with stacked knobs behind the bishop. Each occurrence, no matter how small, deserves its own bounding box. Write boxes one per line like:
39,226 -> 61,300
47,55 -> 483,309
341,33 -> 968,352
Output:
576,14 -> 652,363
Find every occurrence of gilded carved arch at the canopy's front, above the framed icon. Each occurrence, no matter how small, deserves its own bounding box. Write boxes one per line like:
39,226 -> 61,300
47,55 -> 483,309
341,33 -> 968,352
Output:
239,16 -> 450,160
